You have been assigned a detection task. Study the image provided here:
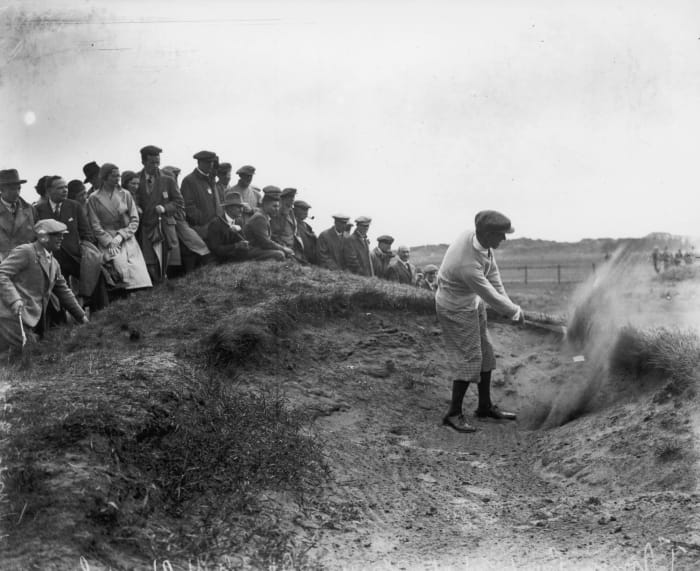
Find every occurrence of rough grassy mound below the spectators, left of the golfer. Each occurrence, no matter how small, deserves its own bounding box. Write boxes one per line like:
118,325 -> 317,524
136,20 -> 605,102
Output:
3,263 -> 434,567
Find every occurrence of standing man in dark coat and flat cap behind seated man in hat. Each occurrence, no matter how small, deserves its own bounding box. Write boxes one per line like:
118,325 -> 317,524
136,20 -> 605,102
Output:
180,151 -> 223,271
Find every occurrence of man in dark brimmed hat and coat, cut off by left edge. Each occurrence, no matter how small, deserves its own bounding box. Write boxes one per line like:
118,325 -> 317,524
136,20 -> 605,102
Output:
0,169 -> 34,261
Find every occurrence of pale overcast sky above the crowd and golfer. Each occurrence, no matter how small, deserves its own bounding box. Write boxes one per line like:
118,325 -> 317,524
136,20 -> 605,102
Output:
0,0 -> 700,246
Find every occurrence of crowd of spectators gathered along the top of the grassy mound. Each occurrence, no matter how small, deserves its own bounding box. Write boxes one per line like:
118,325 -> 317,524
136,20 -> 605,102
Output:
0,145 -> 438,351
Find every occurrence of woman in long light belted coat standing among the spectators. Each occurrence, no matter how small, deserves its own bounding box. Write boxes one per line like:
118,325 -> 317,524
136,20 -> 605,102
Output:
88,163 -> 152,290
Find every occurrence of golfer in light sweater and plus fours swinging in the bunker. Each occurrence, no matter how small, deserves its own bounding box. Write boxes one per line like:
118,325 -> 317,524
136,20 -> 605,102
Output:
435,210 -> 523,432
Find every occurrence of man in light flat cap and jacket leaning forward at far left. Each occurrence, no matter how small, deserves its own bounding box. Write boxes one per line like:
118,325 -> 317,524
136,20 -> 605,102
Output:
0,218 -> 87,351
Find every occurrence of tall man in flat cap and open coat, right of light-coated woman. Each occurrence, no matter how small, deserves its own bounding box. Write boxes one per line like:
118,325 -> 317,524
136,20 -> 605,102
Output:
134,145 -> 185,285
